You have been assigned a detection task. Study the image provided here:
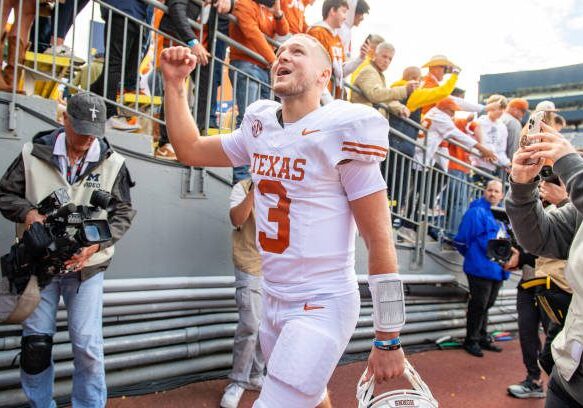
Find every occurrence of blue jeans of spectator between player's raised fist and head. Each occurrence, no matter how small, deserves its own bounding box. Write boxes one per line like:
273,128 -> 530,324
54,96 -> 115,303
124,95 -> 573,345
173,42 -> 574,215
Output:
229,60 -> 270,184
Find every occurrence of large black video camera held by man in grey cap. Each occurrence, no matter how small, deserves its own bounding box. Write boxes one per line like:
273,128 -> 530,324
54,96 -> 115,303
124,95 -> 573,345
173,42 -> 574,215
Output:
1,188 -> 115,293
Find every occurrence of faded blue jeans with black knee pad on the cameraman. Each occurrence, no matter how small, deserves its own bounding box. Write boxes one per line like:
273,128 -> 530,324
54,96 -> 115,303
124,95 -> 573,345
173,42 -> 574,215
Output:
20,273 -> 107,408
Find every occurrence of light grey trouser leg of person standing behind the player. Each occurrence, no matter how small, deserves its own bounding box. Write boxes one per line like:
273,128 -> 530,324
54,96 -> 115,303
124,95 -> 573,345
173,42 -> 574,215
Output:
229,268 -> 265,387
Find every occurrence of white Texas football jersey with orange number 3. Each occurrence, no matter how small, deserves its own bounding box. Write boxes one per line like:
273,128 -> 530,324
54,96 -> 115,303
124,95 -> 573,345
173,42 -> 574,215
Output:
221,100 -> 389,301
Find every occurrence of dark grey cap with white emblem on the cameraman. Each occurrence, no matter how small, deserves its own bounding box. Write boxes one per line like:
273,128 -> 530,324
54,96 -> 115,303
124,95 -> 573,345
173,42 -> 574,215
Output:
67,92 -> 107,138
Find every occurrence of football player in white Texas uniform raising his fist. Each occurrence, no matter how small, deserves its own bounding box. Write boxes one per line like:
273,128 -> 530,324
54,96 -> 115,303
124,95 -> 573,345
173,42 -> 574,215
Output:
161,34 -> 405,408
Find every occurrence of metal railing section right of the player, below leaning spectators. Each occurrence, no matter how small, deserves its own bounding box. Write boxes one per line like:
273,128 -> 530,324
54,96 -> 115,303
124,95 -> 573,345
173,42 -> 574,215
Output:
344,83 -> 504,268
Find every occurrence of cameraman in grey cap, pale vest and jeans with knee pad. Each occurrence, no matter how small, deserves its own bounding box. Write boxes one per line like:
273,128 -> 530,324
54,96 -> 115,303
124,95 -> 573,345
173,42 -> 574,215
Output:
0,93 -> 135,407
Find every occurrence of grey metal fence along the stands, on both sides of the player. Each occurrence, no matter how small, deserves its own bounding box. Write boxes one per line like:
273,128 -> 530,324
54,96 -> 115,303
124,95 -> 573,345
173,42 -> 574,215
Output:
0,0 -> 506,267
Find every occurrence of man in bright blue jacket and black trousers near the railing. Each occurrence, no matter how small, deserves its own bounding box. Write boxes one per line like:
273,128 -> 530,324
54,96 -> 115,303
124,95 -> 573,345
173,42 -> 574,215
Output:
455,180 -> 515,357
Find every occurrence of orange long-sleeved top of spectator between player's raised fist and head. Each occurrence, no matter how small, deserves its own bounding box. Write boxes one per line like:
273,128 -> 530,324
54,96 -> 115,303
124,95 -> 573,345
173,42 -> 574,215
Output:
229,0 -> 289,68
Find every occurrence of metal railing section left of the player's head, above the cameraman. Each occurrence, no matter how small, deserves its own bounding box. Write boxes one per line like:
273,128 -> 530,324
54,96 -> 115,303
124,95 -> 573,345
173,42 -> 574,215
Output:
6,0 -> 273,137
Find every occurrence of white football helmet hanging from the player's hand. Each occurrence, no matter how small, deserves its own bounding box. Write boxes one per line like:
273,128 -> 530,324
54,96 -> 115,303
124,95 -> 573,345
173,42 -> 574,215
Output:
356,360 -> 438,408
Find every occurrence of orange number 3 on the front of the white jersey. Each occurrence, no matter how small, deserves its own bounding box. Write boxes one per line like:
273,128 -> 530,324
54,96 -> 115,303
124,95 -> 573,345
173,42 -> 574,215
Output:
257,180 -> 291,254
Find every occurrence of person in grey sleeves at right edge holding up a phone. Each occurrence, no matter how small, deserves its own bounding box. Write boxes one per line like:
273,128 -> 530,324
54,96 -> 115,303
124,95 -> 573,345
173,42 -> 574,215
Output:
506,124 -> 583,408
